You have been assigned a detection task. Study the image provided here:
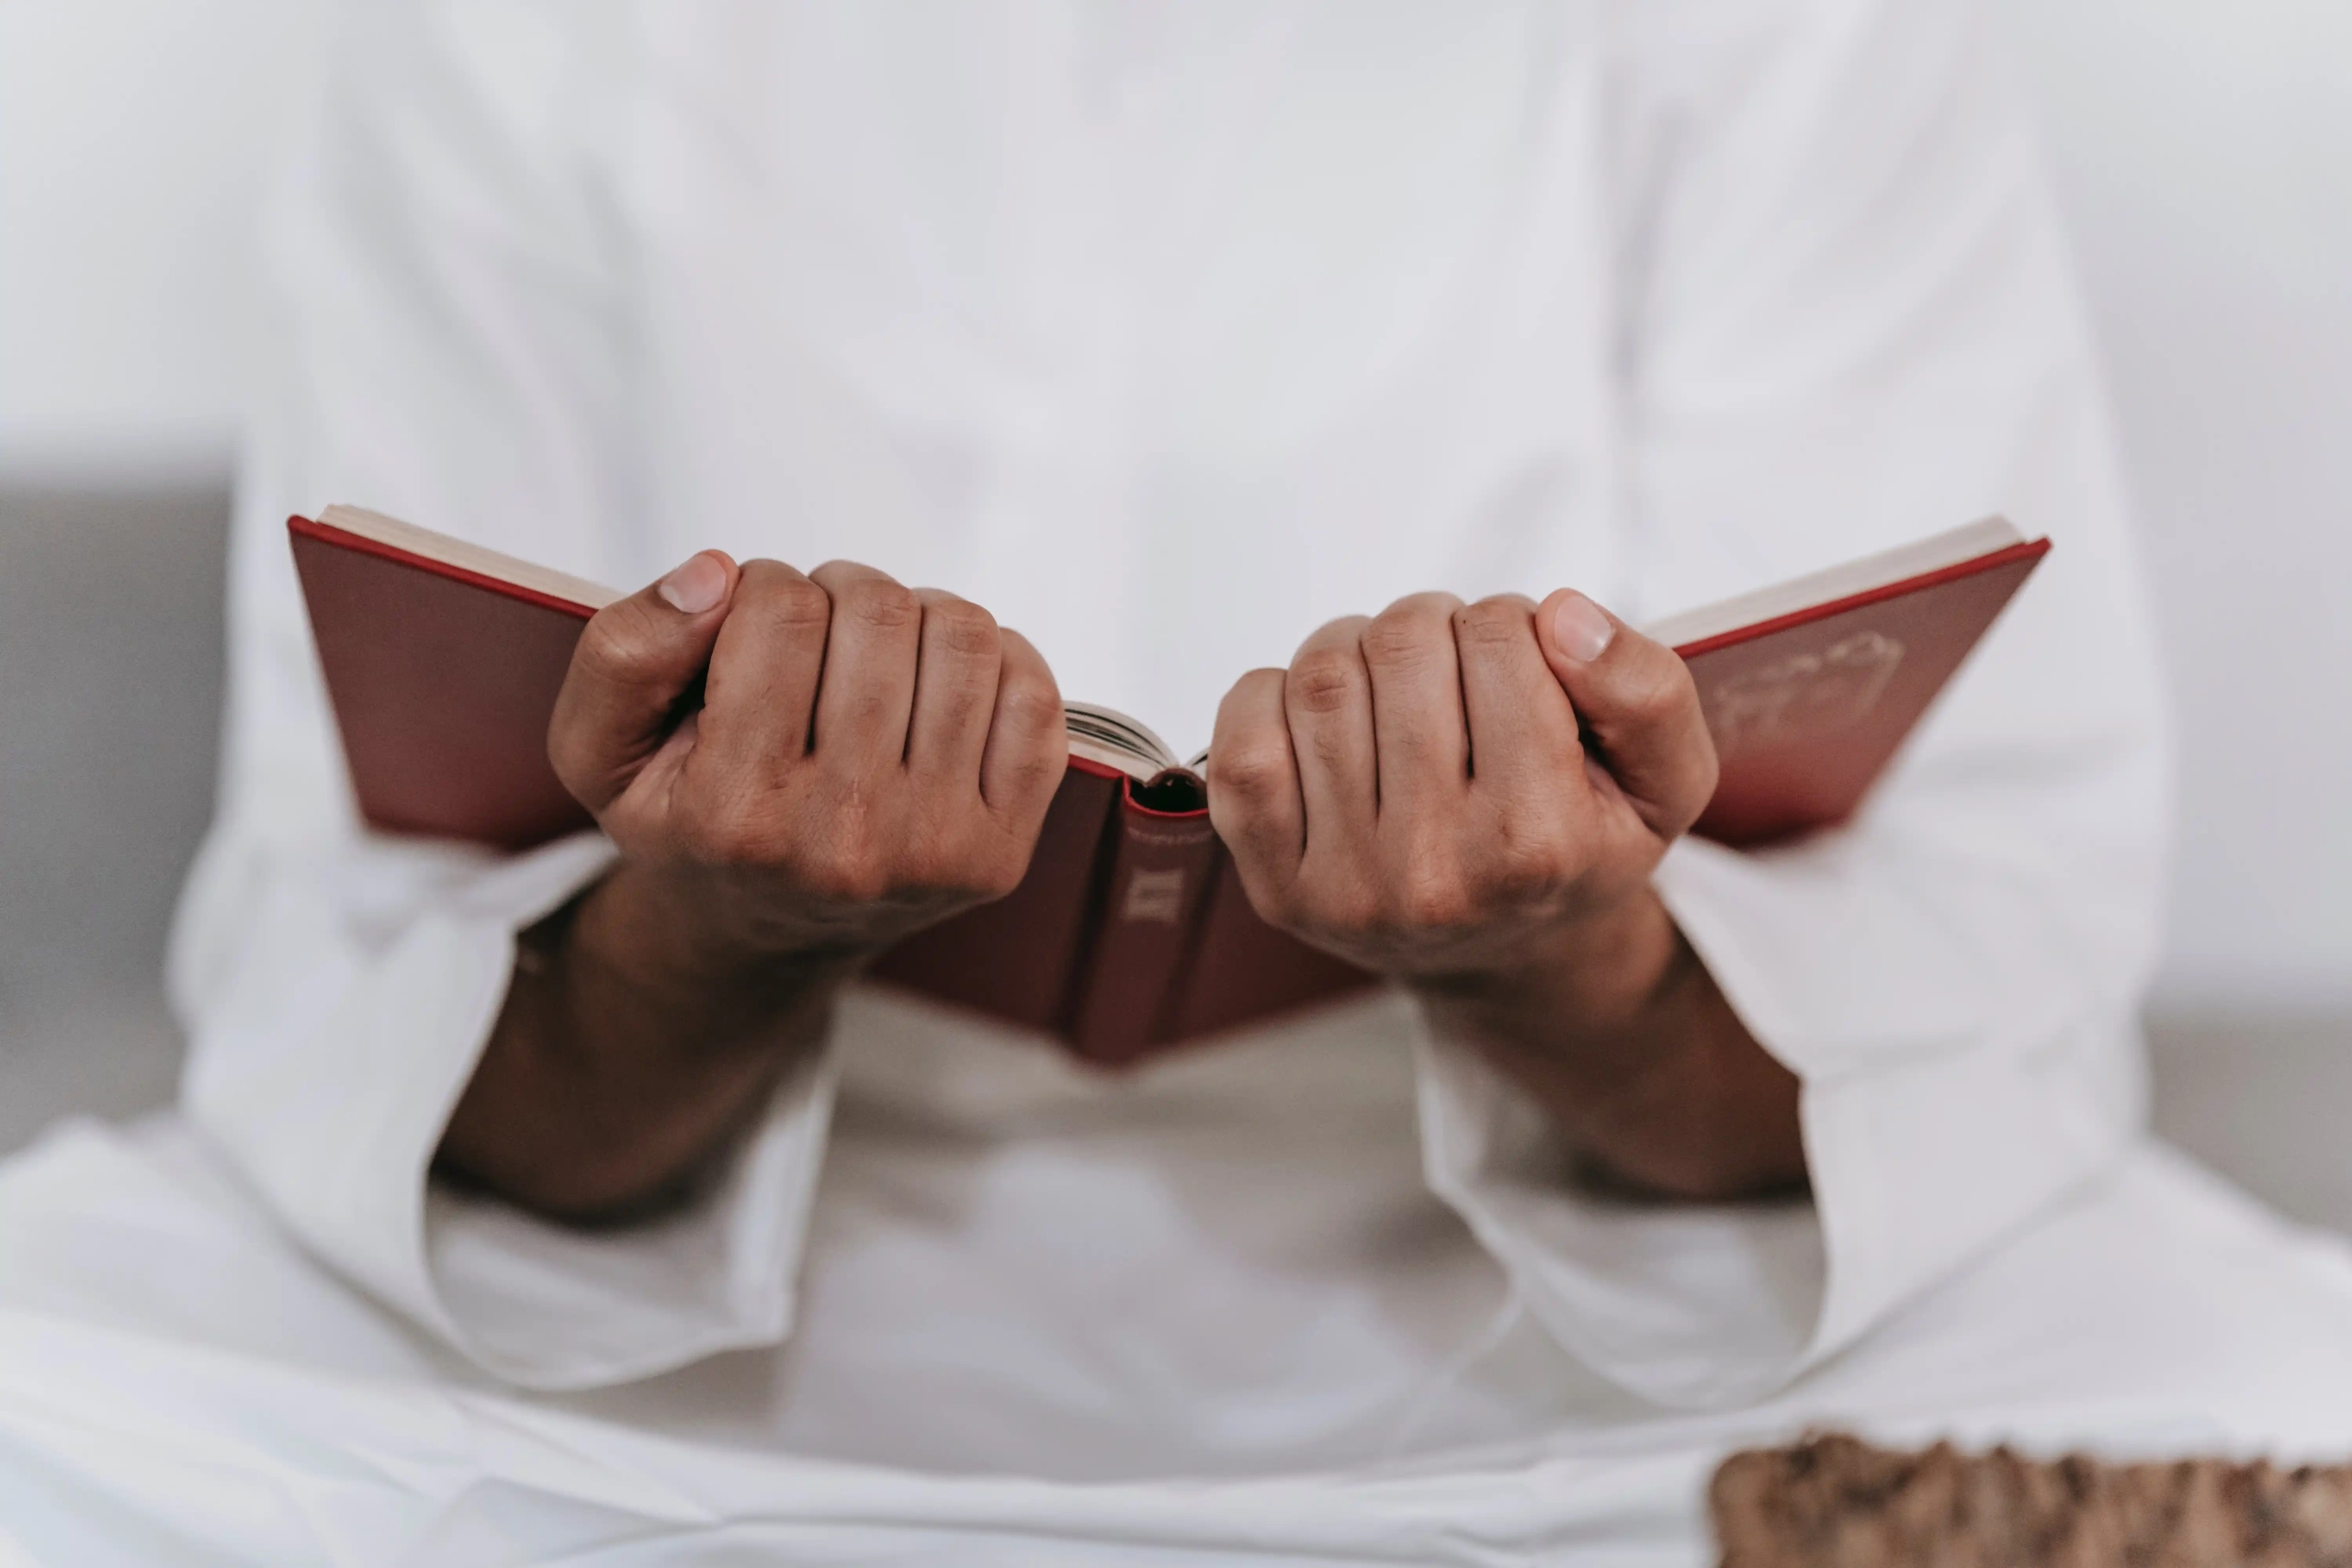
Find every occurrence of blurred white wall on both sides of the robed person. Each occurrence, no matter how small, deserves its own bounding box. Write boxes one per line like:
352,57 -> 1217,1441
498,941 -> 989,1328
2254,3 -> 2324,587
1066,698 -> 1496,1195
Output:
0,0 -> 2352,1009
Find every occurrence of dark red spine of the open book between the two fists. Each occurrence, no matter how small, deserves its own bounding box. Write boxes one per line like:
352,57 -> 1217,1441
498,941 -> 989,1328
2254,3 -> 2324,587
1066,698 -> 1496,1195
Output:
1068,790 -> 1218,1067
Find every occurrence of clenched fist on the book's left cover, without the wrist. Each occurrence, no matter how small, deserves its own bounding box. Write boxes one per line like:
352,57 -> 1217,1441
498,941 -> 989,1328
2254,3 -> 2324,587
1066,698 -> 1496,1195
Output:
548,550 -> 1068,962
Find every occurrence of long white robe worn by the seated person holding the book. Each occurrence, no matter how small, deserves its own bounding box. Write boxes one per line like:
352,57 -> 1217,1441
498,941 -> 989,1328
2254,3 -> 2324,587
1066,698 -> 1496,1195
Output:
0,0 -> 2352,1561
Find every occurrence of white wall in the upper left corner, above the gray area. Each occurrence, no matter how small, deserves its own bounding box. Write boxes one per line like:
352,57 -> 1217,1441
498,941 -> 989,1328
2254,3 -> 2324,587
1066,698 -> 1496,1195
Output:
0,0 -> 332,479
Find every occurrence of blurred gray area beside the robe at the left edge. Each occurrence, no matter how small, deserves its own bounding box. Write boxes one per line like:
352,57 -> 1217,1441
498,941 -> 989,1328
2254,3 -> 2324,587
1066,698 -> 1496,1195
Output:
0,487 -> 228,1149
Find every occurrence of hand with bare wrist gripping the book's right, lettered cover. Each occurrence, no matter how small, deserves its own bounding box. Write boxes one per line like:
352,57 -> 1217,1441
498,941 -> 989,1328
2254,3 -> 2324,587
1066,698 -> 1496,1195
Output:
1209,590 -> 1804,1197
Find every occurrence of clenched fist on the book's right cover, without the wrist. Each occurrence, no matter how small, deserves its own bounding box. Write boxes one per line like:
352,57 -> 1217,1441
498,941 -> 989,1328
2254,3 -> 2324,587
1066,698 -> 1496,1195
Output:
1209,590 -> 1714,1006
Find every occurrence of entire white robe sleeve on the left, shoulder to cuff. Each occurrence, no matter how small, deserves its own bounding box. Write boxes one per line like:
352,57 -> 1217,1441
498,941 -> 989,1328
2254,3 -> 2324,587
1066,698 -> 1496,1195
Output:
172,3 -> 831,1387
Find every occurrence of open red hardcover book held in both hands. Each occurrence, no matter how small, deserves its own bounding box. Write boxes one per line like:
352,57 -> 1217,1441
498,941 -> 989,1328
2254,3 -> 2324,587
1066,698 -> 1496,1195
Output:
287,505 -> 2049,1065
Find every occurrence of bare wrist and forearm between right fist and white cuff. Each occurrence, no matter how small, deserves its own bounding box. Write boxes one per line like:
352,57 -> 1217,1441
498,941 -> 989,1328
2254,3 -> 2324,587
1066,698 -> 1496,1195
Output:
1419,894 -> 1806,1199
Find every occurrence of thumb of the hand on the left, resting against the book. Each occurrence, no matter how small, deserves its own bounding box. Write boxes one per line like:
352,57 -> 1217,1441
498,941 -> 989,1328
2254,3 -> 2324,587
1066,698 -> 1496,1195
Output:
548,550 -> 739,811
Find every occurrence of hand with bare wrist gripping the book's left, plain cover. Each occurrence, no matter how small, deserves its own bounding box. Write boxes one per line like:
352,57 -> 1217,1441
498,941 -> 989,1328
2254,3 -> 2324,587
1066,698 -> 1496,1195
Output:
440,550 -> 1066,1218
